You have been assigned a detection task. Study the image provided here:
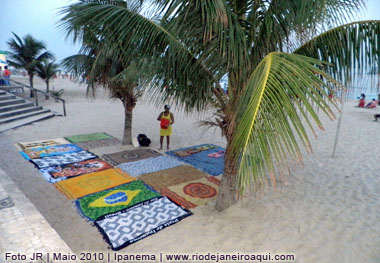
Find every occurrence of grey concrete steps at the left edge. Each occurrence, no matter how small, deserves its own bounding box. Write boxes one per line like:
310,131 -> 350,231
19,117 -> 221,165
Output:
0,87 -> 55,133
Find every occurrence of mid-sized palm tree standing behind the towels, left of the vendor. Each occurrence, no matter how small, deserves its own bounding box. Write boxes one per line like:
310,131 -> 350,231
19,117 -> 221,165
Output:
62,15 -> 149,145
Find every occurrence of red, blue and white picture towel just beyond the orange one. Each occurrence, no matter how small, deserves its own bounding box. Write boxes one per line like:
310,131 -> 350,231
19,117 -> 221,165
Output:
40,159 -> 112,184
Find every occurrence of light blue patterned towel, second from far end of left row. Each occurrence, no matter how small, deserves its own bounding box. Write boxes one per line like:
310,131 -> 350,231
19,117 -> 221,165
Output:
21,144 -> 83,160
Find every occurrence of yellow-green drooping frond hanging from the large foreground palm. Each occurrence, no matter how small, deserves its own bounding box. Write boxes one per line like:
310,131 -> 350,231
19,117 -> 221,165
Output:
232,53 -> 337,193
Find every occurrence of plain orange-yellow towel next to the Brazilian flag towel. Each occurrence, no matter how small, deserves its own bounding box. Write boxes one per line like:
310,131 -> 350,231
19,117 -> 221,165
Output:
54,169 -> 136,200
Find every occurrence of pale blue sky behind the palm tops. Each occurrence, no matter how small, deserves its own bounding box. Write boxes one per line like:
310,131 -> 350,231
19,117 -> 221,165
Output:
0,0 -> 380,60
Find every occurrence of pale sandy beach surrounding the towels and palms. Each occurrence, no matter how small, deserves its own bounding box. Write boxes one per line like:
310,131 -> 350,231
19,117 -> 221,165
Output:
0,77 -> 380,263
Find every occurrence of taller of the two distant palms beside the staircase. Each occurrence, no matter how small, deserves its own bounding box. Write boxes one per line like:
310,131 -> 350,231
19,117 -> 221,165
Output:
7,33 -> 54,97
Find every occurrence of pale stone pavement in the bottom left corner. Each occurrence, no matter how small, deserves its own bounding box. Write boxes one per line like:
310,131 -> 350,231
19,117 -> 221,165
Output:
0,169 -> 75,263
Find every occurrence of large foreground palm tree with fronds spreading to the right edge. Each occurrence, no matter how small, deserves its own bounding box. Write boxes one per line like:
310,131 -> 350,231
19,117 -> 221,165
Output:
62,0 -> 380,210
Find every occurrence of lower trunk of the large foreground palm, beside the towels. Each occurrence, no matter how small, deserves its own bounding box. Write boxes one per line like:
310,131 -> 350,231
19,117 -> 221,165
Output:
216,143 -> 238,211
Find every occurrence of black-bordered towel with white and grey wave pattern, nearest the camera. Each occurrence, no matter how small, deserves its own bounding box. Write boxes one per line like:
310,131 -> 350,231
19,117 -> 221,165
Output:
95,196 -> 191,250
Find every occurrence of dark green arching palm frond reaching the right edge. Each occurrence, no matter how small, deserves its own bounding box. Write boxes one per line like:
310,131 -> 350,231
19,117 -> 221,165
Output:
294,20 -> 380,81
